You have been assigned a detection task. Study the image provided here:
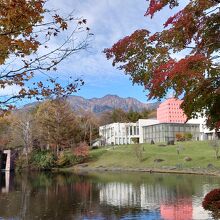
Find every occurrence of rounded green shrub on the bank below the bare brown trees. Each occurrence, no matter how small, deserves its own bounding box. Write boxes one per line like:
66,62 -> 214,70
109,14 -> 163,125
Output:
30,150 -> 55,170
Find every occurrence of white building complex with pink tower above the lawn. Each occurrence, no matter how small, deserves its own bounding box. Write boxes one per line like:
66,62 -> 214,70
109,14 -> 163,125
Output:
99,98 -> 217,145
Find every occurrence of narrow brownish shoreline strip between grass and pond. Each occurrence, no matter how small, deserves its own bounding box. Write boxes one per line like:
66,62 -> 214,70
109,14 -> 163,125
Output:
59,164 -> 220,177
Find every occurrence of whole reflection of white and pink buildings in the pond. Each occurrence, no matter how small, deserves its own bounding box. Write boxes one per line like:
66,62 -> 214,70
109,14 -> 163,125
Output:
99,182 -> 212,220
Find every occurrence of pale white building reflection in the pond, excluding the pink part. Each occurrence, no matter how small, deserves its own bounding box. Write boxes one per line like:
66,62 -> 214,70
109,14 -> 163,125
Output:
100,183 -> 176,209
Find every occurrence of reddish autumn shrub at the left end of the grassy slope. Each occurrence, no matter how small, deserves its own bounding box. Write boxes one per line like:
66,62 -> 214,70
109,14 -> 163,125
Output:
73,142 -> 89,163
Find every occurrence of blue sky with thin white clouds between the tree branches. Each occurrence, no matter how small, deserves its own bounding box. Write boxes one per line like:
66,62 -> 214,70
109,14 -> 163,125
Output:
0,0 -> 188,105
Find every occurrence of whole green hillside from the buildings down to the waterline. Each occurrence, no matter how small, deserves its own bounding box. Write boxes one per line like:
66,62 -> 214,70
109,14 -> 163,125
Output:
70,141 -> 220,175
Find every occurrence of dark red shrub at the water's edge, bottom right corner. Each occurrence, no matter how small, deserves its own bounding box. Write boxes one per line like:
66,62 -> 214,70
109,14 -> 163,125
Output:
202,189 -> 220,211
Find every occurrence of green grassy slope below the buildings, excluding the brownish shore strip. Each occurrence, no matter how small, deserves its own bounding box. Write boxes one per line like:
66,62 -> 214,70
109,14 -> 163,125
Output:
89,141 -> 220,168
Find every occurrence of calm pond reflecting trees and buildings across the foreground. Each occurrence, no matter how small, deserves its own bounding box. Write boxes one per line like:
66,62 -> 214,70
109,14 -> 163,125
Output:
0,172 -> 220,220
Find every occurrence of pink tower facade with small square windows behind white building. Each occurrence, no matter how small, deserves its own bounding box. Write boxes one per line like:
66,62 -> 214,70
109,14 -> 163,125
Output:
157,98 -> 187,123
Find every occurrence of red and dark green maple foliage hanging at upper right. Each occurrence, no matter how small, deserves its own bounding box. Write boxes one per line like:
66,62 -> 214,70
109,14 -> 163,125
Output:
104,0 -> 220,129
